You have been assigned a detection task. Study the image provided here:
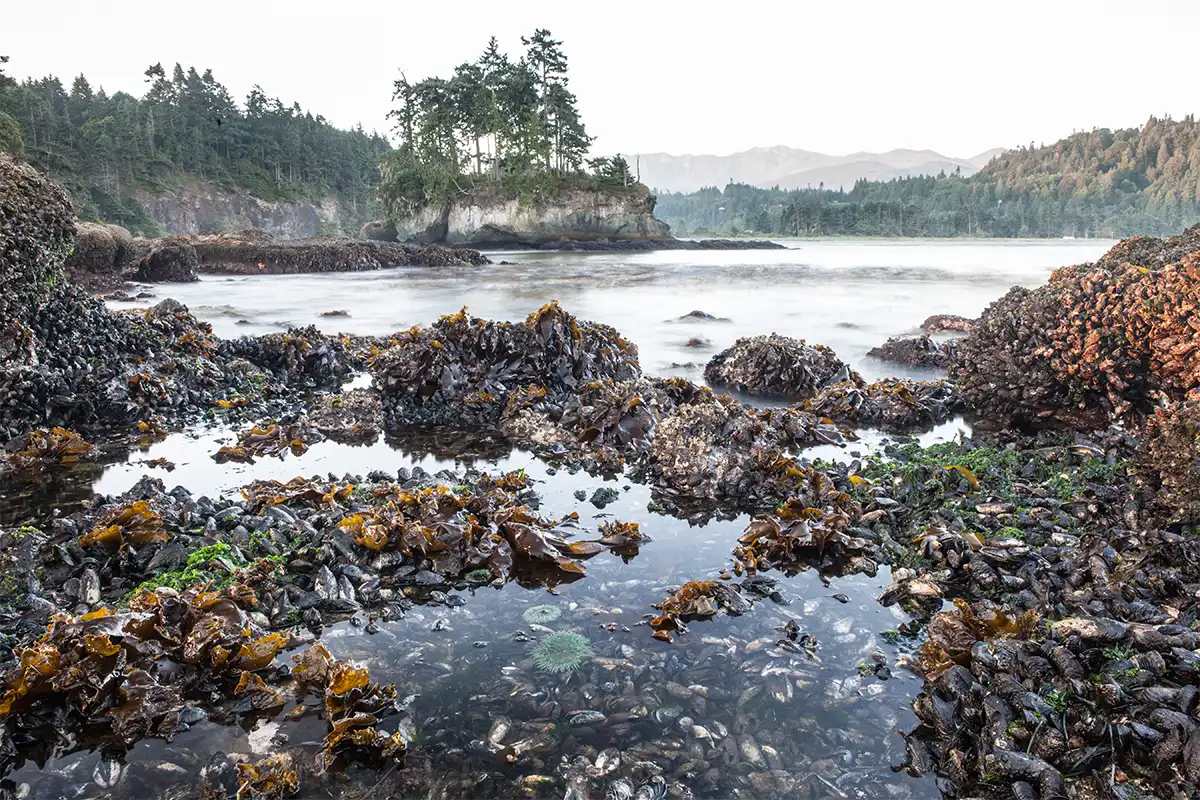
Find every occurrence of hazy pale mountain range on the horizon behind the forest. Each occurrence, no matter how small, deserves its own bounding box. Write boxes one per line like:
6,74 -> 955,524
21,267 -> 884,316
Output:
630,146 -> 1003,192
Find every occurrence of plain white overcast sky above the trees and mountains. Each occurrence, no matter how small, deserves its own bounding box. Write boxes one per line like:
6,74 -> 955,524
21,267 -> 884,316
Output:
0,0 -> 1200,157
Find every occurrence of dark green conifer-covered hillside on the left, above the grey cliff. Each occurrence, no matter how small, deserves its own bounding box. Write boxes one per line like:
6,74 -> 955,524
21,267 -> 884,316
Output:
0,53 -> 391,233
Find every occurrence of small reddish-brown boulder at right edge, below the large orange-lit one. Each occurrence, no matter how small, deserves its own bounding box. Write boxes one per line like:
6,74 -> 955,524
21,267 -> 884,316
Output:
1138,392 -> 1200,525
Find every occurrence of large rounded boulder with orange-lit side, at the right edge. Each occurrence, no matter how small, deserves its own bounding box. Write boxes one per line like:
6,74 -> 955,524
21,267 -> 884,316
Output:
952,225 -> 1200,428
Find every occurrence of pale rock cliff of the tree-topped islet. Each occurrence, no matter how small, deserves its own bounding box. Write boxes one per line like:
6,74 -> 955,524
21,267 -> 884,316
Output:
396,187 -> 671,246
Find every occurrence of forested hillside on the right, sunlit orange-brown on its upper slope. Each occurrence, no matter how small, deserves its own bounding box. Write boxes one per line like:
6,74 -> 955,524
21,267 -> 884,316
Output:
658,116 -> 1200,237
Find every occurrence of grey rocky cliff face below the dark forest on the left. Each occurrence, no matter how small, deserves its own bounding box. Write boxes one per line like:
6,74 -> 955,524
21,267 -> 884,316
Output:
137,184 -> 371,239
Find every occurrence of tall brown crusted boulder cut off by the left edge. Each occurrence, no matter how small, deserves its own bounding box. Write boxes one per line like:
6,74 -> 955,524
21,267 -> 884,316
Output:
0,154 -> 74,331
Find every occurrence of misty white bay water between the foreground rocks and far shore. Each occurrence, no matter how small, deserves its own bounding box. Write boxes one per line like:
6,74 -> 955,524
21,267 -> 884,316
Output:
112,239 -> 1114,379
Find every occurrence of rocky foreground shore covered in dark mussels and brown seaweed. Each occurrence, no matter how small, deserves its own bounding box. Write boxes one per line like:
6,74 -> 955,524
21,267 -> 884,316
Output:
0,149 -> 1200,800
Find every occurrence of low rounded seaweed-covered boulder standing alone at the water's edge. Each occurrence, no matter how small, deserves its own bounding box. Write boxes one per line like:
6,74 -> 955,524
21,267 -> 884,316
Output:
704,333 -> 863,399
